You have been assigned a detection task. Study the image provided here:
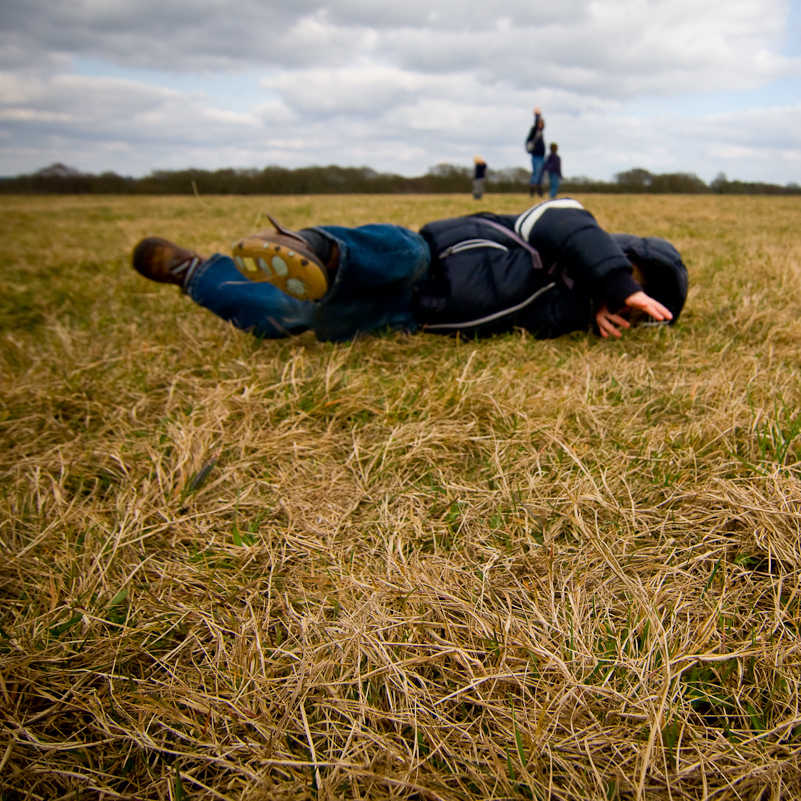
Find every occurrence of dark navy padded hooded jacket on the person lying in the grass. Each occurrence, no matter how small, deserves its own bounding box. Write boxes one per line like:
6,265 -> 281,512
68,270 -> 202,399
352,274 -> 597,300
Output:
415,199 -> 686,338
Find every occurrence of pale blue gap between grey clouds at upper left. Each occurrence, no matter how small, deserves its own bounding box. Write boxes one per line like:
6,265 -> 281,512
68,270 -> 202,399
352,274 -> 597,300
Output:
72,58 -> 278,113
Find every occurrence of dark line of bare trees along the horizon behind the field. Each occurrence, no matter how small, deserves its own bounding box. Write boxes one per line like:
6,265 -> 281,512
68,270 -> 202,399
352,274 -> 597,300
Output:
0,164 -> 801,195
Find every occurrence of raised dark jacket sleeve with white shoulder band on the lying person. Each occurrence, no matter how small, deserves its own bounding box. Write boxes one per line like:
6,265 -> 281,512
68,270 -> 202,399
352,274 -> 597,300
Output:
514,198 -> 641,311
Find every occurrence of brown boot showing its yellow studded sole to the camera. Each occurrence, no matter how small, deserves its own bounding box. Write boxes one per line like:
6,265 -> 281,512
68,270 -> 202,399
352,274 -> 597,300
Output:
233,214 -> 328,300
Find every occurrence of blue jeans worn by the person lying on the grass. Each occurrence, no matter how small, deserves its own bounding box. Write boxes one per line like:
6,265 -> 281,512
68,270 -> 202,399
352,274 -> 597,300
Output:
186,223 -> 431,342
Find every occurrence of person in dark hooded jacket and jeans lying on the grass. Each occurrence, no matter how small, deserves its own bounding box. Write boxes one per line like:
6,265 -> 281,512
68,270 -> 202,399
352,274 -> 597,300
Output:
132,198 -> 687,341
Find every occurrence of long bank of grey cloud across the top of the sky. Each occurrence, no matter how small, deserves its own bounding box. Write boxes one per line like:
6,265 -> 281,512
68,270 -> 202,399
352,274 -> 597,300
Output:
0,0 -> 798,98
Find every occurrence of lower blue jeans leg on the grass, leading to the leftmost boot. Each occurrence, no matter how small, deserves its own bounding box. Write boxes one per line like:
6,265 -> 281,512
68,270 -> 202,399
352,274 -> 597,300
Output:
186,253 -> 314,339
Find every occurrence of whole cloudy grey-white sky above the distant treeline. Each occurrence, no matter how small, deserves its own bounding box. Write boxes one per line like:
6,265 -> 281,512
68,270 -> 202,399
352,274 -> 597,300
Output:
0,0 -> 801,184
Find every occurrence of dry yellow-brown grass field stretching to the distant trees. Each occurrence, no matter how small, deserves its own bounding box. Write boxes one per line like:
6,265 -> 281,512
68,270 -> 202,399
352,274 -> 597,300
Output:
0,195 -> 801,801
